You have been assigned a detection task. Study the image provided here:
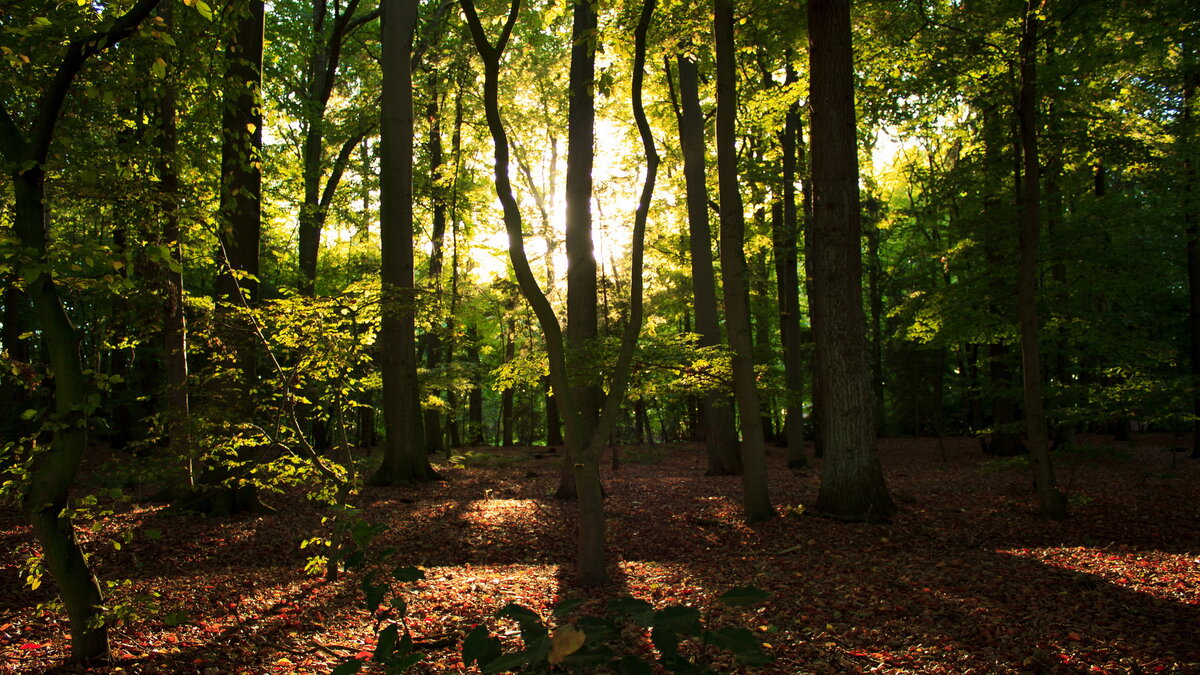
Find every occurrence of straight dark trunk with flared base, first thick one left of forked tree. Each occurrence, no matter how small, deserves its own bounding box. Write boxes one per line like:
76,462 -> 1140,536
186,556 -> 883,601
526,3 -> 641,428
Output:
371,0 -> 437,485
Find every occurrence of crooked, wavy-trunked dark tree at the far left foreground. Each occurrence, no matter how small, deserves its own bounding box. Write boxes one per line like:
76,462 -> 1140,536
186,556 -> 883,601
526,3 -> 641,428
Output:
0,0 -> 158,661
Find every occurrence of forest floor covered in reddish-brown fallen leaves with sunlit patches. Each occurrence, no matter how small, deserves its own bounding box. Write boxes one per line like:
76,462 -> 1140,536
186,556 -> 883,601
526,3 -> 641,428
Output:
0,436 -> 1200,675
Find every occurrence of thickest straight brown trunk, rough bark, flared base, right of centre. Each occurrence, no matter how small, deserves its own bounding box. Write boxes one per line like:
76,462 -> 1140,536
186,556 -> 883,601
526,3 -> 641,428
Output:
809,0 -> 895,520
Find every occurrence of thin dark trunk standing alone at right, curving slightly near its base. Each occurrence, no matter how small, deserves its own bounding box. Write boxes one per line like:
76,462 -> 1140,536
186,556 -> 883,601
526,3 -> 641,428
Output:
1016,0 -> 1067,519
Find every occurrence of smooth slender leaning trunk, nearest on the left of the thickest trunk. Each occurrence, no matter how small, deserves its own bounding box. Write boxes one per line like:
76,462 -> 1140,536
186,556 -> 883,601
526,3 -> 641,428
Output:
713,0 -> 775,522
